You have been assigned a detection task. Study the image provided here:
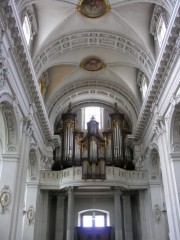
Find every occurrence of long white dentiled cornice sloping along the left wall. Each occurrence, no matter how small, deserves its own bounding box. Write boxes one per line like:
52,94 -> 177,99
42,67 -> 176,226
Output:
0,0 -> 52,141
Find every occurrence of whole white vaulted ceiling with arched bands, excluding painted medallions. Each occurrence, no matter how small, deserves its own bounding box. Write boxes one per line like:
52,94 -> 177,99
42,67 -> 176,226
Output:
16,0 -> 175,136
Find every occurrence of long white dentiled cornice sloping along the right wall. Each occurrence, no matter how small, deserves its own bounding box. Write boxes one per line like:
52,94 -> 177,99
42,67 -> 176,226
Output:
135,2 -> 180,140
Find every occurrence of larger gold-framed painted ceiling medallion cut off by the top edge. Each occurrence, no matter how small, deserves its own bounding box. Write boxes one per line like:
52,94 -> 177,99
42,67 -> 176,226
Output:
77,0 -> 110,18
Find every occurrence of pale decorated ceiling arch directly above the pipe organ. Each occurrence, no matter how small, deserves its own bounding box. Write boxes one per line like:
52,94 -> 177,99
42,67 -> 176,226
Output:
47,80 -> 139,133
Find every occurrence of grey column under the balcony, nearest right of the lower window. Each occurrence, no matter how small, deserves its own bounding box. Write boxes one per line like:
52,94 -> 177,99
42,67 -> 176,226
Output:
114,187 -> 123,240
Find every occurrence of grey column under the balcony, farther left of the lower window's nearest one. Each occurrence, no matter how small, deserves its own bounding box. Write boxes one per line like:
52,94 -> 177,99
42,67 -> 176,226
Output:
55,195 -> 64,240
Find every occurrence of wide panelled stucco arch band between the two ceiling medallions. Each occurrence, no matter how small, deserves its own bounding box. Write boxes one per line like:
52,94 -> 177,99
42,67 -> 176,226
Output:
33,29 -> 154,77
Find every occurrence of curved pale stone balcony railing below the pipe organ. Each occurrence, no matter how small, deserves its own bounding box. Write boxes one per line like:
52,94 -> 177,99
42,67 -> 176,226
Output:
40,166 -> 148,189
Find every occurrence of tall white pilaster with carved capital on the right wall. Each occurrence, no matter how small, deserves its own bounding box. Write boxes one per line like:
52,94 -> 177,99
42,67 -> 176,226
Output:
154,117 -> 180,240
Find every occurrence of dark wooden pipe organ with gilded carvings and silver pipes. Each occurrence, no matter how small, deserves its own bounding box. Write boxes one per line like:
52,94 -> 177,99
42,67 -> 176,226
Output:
52,104 -> 134,179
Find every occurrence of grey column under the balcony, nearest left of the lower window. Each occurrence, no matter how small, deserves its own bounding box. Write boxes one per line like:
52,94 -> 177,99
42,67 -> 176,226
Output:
66,187 -> 74,240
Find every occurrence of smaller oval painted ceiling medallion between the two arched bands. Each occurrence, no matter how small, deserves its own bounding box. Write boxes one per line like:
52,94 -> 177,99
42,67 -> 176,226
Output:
80,56 -> 106,71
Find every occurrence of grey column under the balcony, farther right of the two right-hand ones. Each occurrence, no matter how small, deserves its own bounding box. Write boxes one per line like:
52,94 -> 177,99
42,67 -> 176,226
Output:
123,195 -> 133,240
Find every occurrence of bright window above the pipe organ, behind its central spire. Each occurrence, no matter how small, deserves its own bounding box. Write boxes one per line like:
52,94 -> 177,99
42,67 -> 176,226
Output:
81,106 -> 104,129
